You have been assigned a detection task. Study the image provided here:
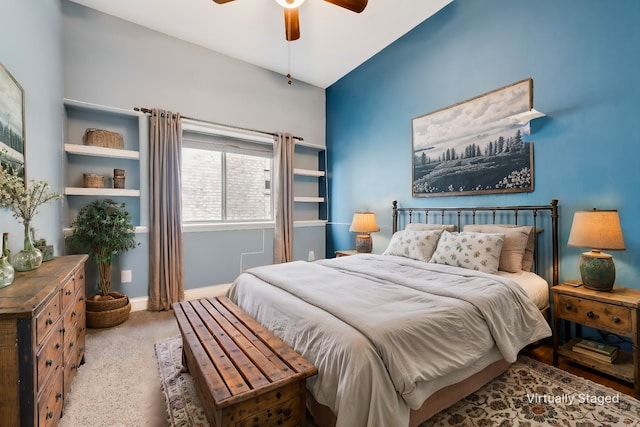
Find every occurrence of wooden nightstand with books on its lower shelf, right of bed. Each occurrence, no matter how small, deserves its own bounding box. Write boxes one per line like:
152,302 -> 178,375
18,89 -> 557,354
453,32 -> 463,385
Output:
552,285 -> 640,396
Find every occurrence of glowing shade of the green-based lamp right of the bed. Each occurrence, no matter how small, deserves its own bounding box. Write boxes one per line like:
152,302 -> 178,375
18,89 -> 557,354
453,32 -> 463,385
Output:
567,209 -> 625,251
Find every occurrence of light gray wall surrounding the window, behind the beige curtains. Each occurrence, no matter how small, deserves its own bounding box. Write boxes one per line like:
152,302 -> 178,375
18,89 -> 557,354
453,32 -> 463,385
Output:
61,1 -> 325,297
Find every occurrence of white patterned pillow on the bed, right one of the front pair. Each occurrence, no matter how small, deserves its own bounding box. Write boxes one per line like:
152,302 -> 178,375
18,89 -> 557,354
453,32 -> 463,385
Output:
431,231 -> 504,274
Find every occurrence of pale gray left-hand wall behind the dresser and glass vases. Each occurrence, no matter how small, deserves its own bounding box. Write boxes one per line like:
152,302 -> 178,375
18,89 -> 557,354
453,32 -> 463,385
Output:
0,0 -> 63,254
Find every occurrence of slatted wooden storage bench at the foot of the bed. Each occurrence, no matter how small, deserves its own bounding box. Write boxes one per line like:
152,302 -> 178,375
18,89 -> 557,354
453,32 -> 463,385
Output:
172,297 -> 318,427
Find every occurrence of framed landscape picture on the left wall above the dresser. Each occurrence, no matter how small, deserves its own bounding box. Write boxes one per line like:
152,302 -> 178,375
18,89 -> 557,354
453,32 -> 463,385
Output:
0,63 -> 25,173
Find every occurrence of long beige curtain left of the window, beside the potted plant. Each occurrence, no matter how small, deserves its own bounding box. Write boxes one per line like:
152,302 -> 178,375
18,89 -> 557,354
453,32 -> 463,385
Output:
147,109 -> 184,311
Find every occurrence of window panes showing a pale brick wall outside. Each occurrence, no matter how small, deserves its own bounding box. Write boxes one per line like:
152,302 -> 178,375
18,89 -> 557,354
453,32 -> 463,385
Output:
182,147 -> 272,222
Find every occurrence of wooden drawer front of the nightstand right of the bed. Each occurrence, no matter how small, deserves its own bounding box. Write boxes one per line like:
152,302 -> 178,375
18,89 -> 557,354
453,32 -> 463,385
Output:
556,295 -> 633,335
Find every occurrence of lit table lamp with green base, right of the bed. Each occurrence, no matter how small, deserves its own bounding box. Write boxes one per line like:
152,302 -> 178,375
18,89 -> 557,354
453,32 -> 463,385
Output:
567,209 -> 625,291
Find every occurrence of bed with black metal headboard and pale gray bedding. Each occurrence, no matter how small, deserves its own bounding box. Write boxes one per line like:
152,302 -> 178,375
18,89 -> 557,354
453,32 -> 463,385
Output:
228,200 -> 558,427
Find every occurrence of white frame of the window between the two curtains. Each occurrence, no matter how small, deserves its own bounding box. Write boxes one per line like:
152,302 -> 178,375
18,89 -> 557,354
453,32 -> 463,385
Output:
182,118 -> 275,232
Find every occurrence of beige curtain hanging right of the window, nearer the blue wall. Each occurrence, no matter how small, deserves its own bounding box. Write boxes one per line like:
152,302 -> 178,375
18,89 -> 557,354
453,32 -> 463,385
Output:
273,133 -> 295,264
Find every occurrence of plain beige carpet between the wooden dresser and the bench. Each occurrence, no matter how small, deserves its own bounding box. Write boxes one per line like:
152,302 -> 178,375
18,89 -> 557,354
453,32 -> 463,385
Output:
61,311 -> 180,427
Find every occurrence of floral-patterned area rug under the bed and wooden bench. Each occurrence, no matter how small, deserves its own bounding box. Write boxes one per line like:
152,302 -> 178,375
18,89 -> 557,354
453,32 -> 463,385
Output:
155,337 -> 640,427
